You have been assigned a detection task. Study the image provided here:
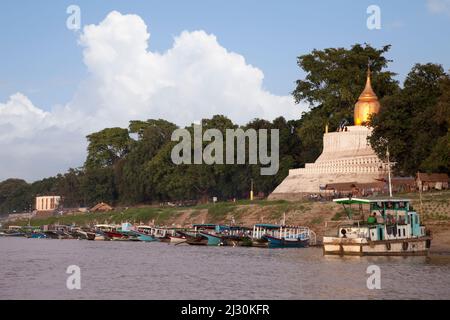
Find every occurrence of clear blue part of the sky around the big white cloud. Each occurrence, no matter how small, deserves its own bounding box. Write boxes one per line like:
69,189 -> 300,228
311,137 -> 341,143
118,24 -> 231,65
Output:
0,0 -> 450,110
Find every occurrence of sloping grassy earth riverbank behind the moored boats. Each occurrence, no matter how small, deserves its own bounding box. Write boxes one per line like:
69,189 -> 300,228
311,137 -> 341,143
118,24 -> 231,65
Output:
6,191 -> 450,254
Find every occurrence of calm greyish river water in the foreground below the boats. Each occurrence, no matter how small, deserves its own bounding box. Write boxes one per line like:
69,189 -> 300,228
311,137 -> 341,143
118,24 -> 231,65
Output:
0,238 -> 450,299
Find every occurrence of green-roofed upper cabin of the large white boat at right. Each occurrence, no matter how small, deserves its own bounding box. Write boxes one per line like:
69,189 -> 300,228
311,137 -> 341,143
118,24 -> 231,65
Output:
334,198 -> 425,241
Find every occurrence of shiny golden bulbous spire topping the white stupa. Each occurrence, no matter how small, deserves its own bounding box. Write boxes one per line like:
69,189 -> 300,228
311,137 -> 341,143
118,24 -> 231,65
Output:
354,65 -> 380,126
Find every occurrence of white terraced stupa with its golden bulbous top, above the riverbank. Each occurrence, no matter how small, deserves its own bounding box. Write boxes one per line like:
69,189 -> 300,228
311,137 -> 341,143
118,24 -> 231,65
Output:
269,70 -> 383,200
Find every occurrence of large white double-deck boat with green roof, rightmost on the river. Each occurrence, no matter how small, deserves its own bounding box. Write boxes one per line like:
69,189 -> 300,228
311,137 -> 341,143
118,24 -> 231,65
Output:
323,198 -> 432,256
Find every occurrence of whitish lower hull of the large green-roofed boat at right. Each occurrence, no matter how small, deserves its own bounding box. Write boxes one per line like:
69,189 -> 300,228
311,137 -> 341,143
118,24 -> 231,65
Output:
323,237 -> 432,256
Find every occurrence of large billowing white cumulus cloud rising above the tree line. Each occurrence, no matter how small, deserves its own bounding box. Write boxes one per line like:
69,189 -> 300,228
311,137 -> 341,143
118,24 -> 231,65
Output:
0,11 -> 305,180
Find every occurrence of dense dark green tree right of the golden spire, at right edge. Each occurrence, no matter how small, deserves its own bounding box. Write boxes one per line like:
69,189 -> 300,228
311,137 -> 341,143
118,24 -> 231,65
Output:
370,63 -> 448,175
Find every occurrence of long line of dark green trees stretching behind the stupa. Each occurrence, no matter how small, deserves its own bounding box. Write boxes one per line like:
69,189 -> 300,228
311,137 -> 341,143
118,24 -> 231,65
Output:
0,44 -> 450,214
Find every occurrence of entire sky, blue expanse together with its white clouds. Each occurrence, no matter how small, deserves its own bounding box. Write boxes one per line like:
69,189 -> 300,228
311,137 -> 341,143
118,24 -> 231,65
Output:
0,0 -> 450,181
